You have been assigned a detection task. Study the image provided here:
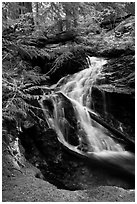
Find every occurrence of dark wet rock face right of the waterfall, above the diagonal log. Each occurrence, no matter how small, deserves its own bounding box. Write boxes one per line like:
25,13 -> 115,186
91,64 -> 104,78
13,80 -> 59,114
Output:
91,55 -> 135,139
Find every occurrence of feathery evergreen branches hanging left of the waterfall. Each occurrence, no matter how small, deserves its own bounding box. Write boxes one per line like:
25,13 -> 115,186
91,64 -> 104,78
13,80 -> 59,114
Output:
2,41 -> 47,135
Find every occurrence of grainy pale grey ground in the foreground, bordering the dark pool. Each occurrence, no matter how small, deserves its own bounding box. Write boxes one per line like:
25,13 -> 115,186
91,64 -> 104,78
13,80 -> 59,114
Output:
2,155 -> 135,202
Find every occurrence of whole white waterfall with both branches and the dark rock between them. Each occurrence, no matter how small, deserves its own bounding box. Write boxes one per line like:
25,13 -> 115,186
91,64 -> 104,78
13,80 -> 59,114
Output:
40,57 -> 134,174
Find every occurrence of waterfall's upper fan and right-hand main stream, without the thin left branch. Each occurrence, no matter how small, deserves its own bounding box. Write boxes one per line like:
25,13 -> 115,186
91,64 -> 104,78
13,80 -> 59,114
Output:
61,57 -> 123,152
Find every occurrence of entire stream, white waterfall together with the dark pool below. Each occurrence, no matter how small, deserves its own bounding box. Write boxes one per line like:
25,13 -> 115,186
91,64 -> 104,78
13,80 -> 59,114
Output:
20,57 -> 135,190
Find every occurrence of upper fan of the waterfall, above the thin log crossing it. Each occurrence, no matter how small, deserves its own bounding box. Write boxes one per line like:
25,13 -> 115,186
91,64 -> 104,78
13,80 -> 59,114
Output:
61,57 -> 107,107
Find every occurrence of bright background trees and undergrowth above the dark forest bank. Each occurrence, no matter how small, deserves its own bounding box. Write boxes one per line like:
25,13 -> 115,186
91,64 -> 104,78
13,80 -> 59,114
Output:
2,2 -> 135,35
